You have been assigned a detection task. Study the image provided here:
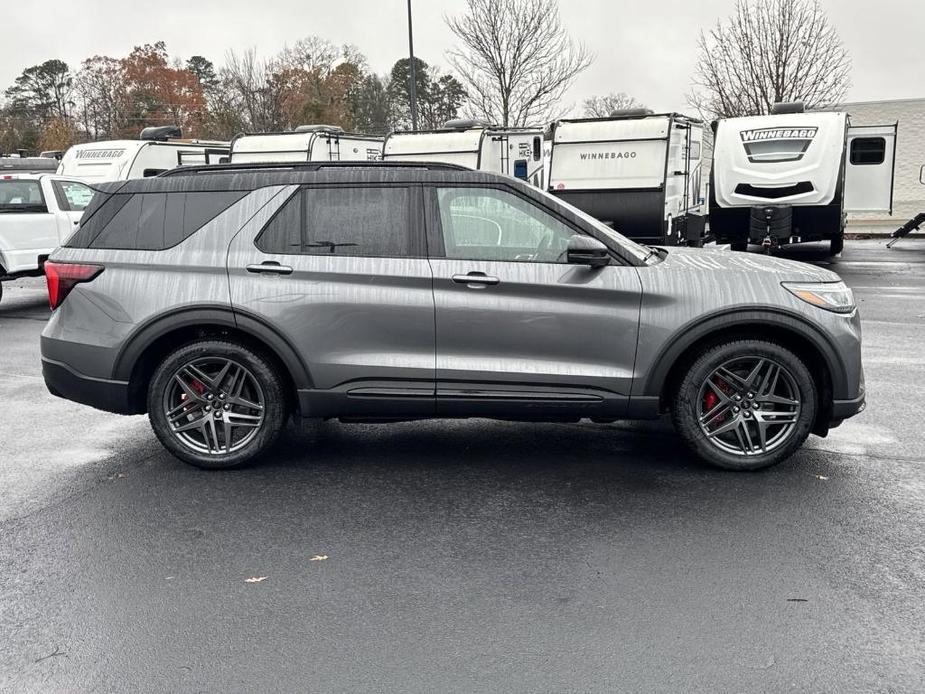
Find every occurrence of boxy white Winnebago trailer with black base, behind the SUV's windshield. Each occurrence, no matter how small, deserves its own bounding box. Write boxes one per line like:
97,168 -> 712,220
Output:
548,109 -> 705,246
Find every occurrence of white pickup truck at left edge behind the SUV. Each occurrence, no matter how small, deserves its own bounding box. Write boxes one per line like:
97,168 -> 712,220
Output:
0,174 -> 93,298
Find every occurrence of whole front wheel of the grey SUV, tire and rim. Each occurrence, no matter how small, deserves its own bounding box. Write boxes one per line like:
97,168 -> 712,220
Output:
672,340 -> 817,470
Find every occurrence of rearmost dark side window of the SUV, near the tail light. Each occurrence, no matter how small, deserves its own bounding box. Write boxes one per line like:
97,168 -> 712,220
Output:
66,191 -> 247,251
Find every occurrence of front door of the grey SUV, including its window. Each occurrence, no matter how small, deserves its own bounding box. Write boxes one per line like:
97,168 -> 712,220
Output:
427,186 -> 641,418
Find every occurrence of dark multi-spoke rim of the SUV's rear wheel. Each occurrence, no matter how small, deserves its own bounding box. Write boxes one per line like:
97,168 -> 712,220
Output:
163,357 -> 266,455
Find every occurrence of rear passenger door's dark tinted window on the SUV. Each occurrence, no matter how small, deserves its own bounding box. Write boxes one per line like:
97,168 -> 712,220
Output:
257,187 -> 417,257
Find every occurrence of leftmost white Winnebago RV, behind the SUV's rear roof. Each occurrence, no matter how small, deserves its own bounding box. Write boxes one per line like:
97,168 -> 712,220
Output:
58,126 -> 228,183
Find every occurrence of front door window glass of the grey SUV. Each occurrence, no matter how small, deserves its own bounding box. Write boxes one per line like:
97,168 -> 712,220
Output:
437,188 -> 576,263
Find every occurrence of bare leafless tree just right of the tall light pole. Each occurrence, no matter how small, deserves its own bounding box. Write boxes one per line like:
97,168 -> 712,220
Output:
445,0 -> 594,126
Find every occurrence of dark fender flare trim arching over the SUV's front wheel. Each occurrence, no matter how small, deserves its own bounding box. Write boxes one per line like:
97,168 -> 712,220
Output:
640,308 -> 848,398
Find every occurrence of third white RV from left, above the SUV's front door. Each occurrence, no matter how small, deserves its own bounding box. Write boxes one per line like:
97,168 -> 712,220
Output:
382,119 -> 544,188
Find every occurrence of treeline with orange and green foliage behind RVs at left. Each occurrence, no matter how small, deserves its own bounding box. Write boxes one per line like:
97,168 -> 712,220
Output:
0,36 -> 466,152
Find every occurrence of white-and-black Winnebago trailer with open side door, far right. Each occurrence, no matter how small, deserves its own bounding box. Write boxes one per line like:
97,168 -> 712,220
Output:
710,104 -> 897,255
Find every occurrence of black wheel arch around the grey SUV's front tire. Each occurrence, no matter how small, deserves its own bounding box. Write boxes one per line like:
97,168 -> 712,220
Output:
645,311 -> 847,434
